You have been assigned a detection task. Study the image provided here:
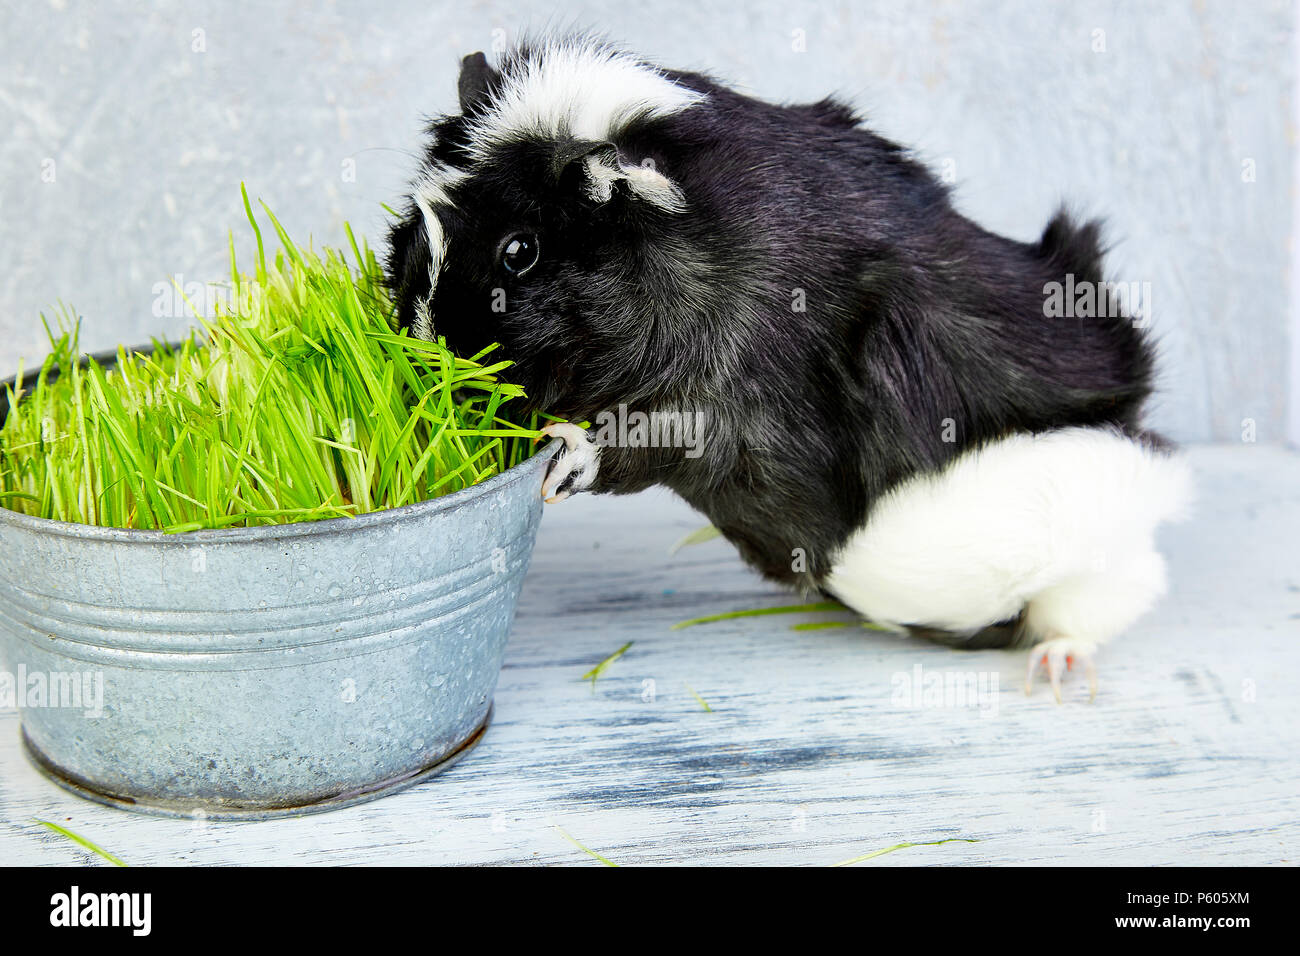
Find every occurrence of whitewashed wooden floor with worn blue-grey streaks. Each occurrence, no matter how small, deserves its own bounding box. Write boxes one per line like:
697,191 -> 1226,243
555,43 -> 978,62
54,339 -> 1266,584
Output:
0,446 -> 1300,866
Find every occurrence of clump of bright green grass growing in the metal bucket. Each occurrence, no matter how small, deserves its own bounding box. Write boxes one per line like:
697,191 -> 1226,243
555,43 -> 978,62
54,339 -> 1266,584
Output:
0,193 -> 540,532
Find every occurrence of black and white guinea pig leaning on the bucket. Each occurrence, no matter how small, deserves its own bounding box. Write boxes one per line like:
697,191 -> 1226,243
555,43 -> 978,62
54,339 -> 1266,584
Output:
386,35 -> 1191,701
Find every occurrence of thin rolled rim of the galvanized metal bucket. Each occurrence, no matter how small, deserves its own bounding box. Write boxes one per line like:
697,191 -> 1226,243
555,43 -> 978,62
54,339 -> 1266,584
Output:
0,346 -> 562,544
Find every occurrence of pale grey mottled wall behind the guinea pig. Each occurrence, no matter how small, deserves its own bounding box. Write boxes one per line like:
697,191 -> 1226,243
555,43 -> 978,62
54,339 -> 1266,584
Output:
0,0 -> 1300,442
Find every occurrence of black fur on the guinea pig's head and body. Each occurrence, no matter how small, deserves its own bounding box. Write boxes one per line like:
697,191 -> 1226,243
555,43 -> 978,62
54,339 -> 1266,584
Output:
389,39 -> 1152,606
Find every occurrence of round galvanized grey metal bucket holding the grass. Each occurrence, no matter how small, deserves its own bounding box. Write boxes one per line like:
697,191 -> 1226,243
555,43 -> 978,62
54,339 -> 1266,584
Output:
0,353 -> 559,819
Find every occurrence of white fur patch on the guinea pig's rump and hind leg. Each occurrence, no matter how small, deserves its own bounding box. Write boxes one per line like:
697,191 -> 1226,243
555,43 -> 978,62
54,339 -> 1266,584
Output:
826,428 -> 1192,643
